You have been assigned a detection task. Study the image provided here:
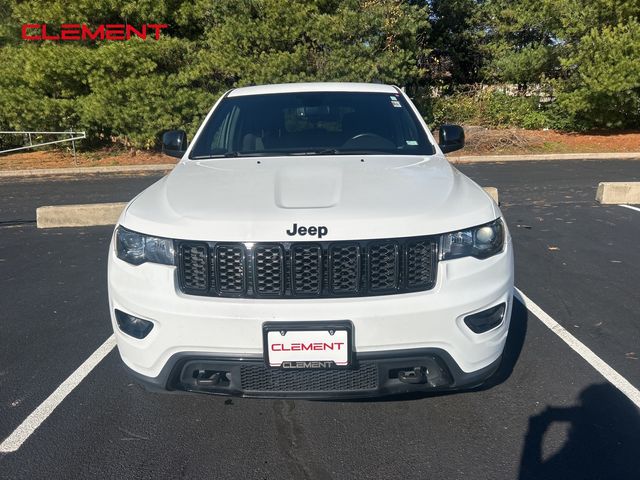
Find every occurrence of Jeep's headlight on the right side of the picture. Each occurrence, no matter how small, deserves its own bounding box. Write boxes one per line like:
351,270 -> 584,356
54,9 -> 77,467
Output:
440,218 -> 504,260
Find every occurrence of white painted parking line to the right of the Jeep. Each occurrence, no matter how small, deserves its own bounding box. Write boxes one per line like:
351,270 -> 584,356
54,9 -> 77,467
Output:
515,288 -> 640,408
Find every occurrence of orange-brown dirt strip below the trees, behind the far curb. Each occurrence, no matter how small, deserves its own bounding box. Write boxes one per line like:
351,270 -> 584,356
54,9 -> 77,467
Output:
0,126 -> 640,170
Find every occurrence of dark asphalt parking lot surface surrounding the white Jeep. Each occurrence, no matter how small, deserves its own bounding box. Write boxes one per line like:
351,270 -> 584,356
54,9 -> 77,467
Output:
0,161 -> 640,479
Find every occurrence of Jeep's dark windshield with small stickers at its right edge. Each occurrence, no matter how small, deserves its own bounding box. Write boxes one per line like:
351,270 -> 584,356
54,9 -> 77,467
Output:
190,92 -> 435,159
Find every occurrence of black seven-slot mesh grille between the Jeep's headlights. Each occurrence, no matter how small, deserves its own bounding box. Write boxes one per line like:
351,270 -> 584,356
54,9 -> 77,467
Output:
177,237 -> 437,298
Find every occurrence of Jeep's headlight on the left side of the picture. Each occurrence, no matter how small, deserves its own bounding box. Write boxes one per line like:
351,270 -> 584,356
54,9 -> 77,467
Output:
116,227 -> 175,265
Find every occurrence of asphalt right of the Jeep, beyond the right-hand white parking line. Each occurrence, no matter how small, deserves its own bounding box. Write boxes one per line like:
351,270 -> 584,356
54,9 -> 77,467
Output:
460,161 -> 640,388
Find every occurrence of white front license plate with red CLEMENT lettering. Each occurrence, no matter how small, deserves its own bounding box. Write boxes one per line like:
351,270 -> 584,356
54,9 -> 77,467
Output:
265,326 -> 351,369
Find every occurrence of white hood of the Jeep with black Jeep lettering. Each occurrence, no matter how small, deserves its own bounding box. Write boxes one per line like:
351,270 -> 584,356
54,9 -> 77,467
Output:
122,155 -> 499,241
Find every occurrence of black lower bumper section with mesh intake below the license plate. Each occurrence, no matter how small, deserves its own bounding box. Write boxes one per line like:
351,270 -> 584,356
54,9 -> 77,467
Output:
122,349 -> 501,399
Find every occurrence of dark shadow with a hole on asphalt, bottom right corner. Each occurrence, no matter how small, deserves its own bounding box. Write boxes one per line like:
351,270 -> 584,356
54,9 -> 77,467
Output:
518,383 -> 640,480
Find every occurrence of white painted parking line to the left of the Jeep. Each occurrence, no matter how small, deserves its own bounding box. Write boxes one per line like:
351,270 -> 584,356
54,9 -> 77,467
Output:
0,335 -> 116,453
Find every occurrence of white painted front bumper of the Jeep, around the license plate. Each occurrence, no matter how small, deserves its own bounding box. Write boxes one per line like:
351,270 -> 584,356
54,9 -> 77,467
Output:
108,237 -> 513,396
